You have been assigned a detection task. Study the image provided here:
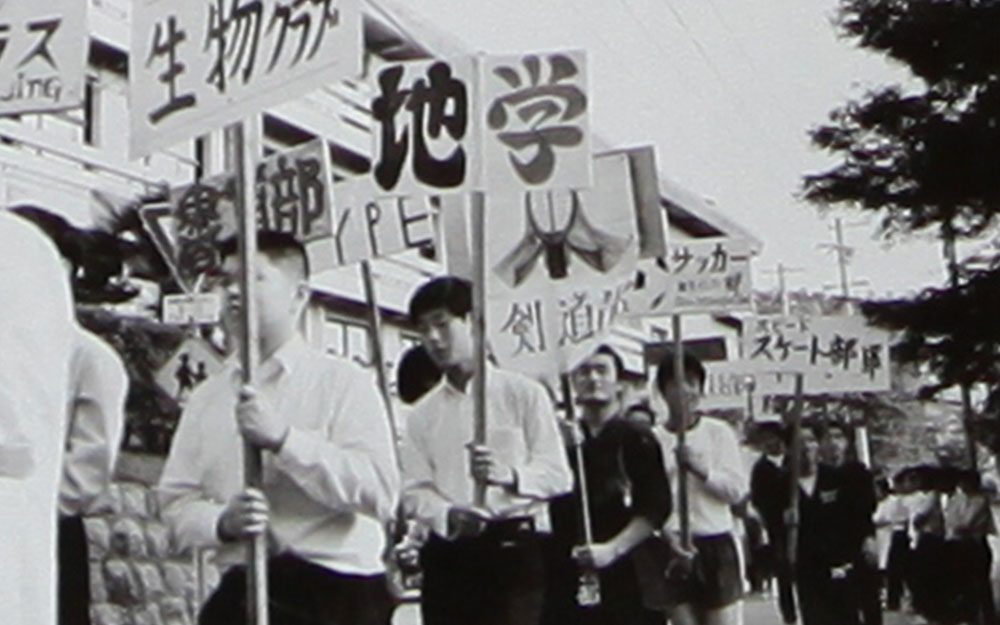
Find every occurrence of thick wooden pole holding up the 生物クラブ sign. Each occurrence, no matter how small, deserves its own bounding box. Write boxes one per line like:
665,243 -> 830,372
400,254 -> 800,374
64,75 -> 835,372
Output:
225,122 -> 268,625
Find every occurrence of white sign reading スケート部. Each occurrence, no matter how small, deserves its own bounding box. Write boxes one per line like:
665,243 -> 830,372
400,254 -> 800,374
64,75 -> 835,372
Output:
743,315 -> 889,393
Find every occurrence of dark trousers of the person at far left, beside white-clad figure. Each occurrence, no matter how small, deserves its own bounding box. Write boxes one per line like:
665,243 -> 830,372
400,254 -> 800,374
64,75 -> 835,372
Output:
58,516 -> 90,625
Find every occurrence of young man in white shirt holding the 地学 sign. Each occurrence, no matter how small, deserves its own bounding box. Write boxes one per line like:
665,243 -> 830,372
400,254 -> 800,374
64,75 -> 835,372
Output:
402,277 -> 572,625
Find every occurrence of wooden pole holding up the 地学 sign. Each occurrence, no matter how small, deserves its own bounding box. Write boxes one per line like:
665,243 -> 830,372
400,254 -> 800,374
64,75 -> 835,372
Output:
471,191 -> 486,507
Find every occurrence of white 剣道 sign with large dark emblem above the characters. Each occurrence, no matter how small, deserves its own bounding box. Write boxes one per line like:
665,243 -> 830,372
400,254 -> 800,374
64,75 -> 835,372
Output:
486,152 -> 656,377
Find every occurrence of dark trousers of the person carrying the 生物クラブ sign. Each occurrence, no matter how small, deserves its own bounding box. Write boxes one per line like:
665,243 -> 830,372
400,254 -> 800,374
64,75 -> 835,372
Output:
198,555 -> 394,625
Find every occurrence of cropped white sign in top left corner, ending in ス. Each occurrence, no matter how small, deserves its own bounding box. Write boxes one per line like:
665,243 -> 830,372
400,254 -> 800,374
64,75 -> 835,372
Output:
0,0 -> 88,115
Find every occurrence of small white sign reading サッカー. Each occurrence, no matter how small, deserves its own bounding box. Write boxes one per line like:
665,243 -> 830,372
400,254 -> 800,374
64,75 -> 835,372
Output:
628,237 -> 752,316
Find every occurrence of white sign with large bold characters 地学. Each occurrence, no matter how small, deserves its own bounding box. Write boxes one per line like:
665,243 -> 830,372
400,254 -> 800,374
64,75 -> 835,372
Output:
372,51 -> 591,196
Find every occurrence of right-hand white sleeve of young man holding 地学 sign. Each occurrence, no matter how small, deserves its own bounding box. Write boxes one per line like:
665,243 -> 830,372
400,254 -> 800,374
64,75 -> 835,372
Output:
514,383 -> 573,499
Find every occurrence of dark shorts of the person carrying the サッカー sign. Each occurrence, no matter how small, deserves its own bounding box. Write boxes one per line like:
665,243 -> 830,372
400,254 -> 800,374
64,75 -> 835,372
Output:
671,534 -> 743,609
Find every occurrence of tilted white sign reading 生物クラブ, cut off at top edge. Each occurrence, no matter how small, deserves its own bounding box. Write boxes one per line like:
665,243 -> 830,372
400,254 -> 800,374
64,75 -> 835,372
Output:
129,0 -> 362,158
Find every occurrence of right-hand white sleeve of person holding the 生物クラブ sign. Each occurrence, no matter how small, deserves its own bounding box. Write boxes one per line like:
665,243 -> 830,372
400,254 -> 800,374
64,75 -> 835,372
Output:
277,371 -> 399,521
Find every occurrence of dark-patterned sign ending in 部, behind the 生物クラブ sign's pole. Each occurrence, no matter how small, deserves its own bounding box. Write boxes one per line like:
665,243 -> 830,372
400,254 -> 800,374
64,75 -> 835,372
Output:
141,139 -> 333,293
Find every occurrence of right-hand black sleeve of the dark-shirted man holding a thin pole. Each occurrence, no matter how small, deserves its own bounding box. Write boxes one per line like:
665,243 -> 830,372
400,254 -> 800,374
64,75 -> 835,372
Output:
621,426 -> 673,527
